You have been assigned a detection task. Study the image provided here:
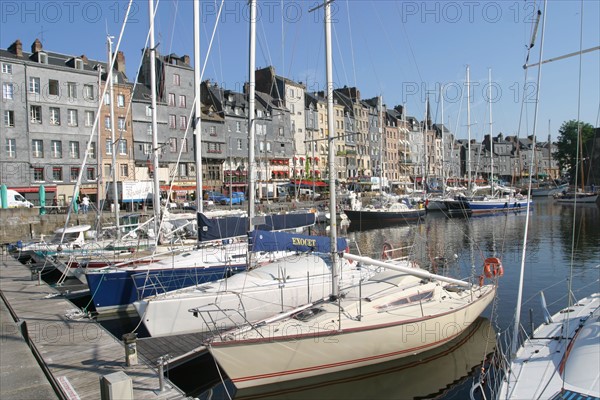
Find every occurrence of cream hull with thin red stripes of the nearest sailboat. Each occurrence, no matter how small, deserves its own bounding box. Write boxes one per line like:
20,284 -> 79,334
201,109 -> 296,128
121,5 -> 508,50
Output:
208,283 -> 495,389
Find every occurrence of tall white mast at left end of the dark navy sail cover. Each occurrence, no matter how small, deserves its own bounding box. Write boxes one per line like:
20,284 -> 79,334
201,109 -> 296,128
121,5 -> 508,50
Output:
194,0 -> 204,214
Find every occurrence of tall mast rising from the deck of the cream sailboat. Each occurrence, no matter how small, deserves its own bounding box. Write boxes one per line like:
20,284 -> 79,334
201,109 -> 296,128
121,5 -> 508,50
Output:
323,0 -> 339,297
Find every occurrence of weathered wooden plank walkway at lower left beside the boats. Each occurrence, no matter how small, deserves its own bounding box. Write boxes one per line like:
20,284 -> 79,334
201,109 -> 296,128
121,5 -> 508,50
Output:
0,256 -> 185,400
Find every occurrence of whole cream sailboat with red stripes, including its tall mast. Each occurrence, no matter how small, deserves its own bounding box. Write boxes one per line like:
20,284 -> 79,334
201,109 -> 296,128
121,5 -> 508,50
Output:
193,1 -> 499,389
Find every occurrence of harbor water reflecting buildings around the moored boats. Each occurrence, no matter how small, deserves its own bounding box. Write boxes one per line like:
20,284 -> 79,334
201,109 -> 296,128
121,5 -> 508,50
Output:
96,198 -> 600,399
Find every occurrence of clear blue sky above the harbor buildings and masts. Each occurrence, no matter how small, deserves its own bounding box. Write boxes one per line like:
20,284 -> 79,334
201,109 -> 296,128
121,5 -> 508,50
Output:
0,0 -> 600,140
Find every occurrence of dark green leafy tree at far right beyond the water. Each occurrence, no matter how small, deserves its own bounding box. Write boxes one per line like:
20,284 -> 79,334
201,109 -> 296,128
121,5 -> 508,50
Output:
553,120 -> 594,181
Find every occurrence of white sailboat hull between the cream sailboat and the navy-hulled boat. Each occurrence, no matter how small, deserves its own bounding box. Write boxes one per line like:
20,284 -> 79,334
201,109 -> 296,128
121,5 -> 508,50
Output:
134,254 -> 376,337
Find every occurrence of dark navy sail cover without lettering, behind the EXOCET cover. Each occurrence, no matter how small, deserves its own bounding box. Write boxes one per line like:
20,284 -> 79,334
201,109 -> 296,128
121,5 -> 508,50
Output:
198,213 -> 316,242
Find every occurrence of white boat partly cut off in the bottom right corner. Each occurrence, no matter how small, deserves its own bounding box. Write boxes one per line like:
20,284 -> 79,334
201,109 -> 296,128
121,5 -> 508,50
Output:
498,293 -> 600,399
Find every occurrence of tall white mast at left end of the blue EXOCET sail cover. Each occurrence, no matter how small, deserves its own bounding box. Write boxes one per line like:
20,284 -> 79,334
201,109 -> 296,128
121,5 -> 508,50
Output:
248,0 -> 256,231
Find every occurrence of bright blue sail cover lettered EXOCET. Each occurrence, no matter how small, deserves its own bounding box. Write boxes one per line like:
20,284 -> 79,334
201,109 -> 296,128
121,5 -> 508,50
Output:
248,230 -> 347,253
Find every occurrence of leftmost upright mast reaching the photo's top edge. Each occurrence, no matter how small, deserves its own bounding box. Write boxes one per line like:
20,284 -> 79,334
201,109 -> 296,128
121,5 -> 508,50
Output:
148,0 -> 161,240
